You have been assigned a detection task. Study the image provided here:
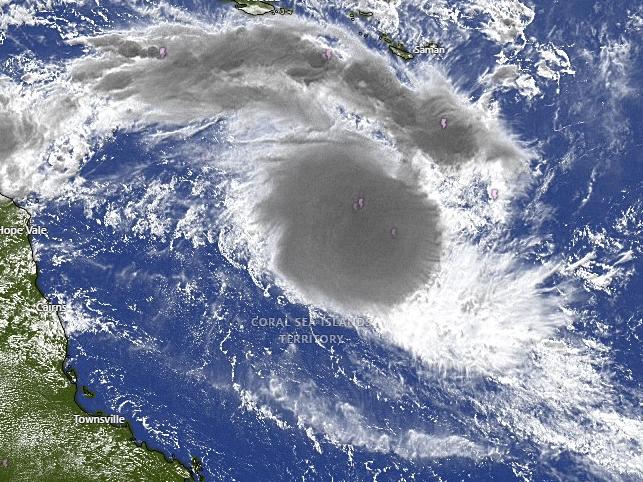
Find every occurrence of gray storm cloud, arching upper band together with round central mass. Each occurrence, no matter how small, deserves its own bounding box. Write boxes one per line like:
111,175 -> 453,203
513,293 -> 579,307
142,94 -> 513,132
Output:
0,19 -> 524,312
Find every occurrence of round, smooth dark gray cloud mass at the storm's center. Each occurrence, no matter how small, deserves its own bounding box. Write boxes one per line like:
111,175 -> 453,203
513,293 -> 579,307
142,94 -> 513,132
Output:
258,145 -> 440,311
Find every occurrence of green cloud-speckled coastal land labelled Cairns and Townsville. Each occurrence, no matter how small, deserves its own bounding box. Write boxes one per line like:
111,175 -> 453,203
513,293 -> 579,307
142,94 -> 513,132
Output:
0,197 -> 190,482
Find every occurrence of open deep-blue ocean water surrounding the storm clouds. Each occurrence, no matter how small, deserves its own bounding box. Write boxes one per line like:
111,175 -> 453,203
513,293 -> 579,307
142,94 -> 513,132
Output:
0,1 -> 643,481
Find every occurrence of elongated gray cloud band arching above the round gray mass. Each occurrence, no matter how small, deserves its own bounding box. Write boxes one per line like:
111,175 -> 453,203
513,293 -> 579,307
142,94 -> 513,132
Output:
73,21 -> 521,164
